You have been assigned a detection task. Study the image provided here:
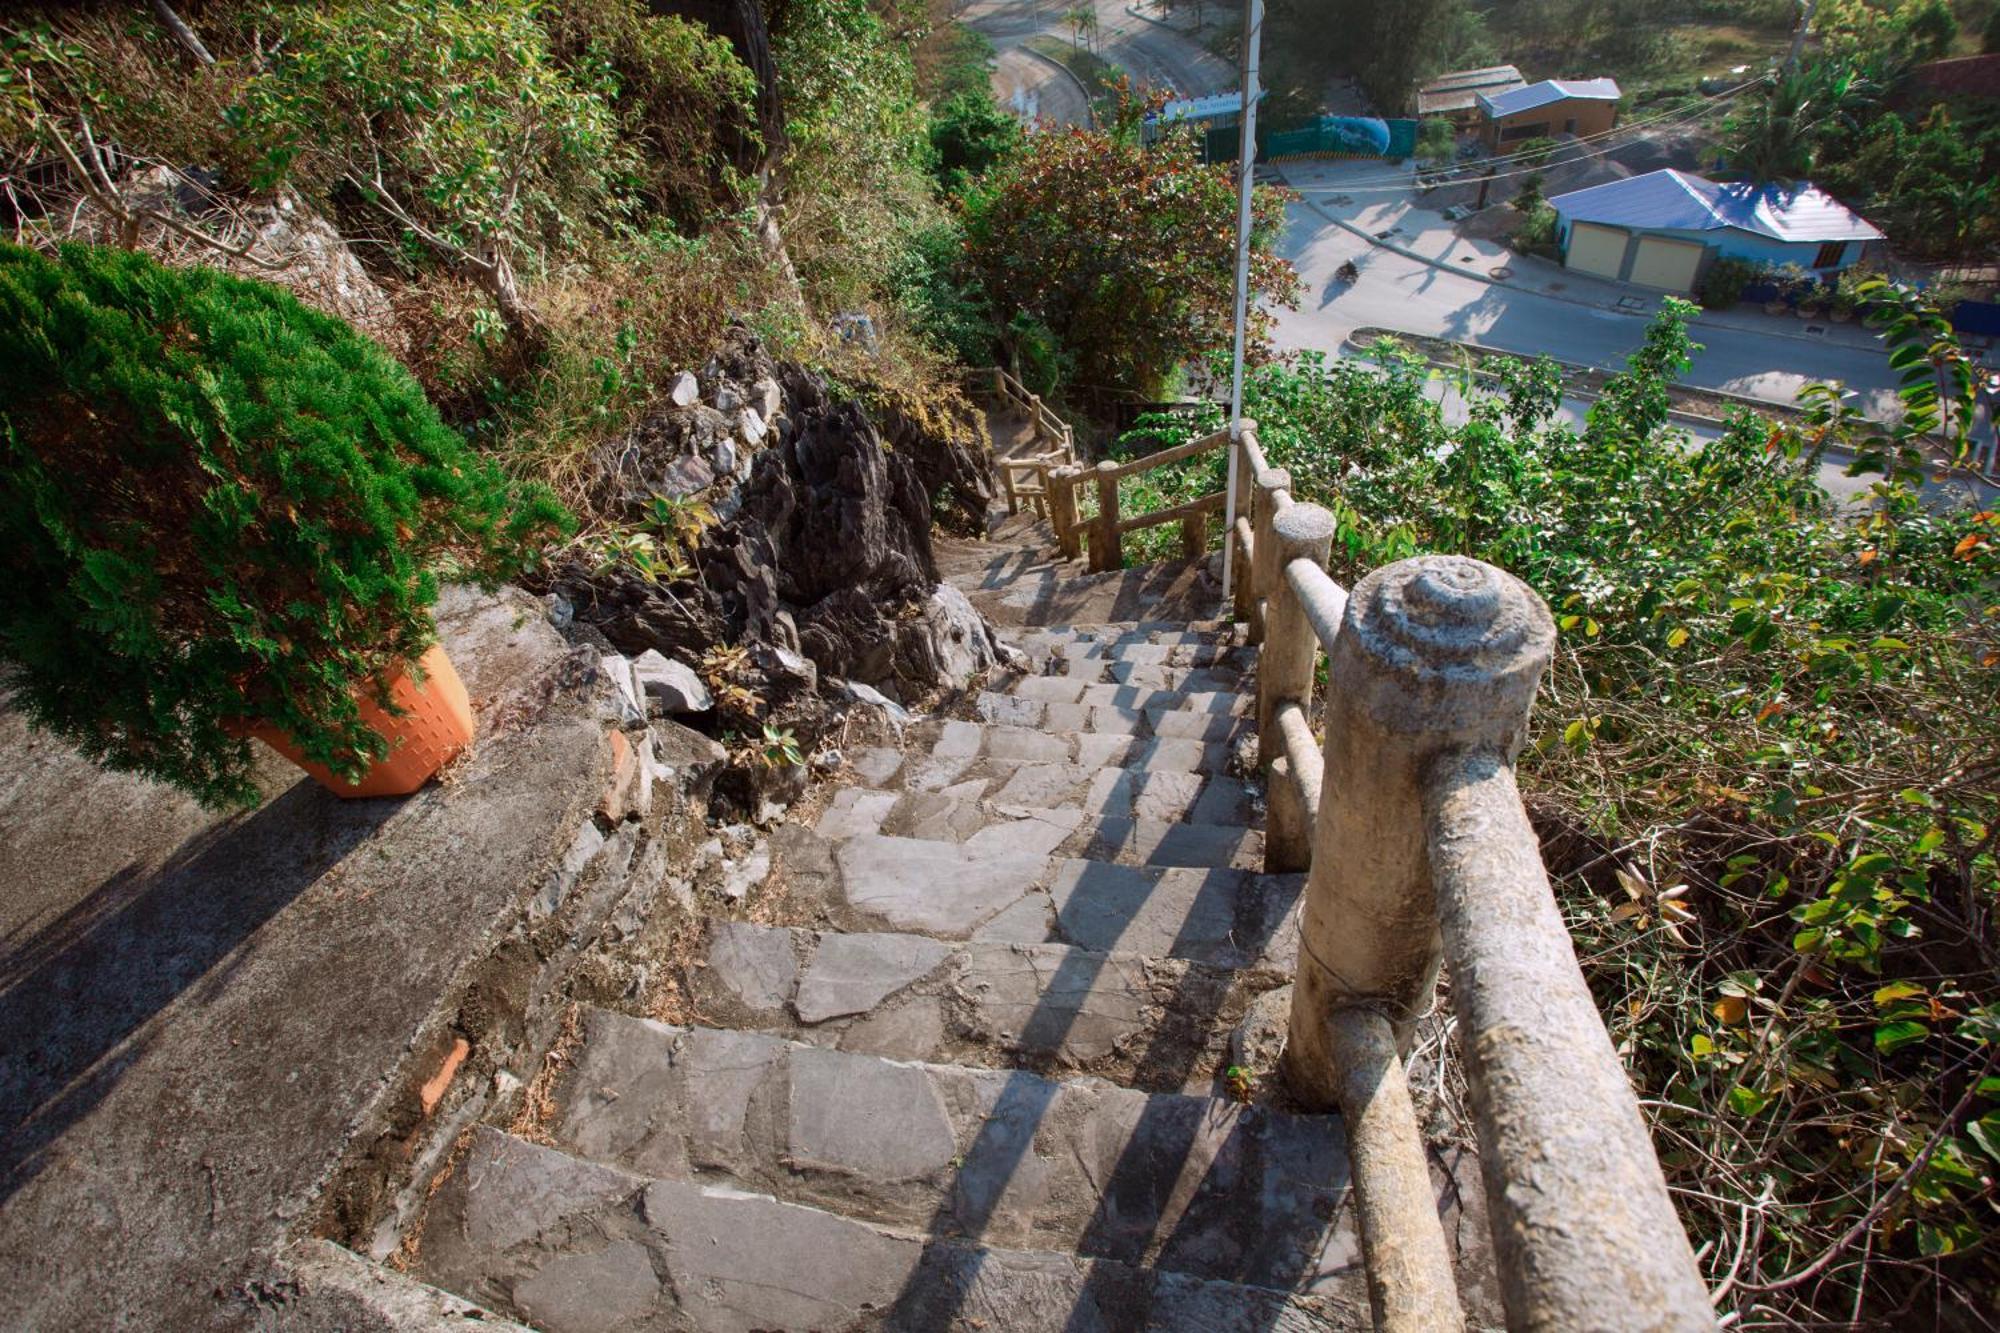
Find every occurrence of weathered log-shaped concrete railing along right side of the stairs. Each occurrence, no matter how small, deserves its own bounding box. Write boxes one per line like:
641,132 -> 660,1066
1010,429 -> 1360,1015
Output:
1104,422 -> 1714,1333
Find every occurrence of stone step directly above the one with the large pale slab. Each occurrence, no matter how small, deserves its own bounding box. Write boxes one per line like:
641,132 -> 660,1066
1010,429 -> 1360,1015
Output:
814,787 -> 1264,871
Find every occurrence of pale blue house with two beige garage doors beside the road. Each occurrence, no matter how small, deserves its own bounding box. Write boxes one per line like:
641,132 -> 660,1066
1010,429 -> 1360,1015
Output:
1548,168 -> 1882,292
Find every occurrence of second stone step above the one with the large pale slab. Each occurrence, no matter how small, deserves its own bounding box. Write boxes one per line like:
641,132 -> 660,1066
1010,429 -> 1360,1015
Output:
850,748 -> 1258,829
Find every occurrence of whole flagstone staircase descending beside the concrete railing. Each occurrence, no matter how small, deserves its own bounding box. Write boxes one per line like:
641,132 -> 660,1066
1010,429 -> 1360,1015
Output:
412,460 -> 1496,1333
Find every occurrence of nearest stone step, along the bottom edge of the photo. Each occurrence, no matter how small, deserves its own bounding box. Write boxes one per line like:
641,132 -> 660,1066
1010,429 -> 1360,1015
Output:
418,1120 -> 1370,1333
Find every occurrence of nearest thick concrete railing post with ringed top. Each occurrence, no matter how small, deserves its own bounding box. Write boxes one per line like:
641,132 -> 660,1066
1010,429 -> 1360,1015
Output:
1266,552 -> 1556,1105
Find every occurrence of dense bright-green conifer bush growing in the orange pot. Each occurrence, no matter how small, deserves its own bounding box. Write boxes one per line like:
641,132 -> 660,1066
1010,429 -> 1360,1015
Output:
0,246 -> 568,805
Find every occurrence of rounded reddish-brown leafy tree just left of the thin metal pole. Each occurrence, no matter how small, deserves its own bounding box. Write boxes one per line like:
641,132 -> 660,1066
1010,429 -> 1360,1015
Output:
966,102 -> 1298,394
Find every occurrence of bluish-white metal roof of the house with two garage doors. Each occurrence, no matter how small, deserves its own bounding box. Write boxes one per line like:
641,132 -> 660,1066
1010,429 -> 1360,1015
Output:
1548,168 -> 1882,242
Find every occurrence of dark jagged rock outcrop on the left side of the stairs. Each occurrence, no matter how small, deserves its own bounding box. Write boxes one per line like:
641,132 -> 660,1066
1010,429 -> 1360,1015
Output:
548,328 -> 998,727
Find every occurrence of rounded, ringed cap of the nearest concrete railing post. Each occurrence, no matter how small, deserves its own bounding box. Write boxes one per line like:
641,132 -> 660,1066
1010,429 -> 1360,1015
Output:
1336,552 -> 1556,755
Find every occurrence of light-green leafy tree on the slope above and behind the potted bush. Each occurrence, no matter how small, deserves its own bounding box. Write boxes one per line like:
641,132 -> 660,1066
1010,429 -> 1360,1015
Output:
236,0 -> 632,350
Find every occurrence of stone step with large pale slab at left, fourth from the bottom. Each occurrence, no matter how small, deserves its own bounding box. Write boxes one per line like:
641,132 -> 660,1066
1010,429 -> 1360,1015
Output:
756,821 -> 1304,973
